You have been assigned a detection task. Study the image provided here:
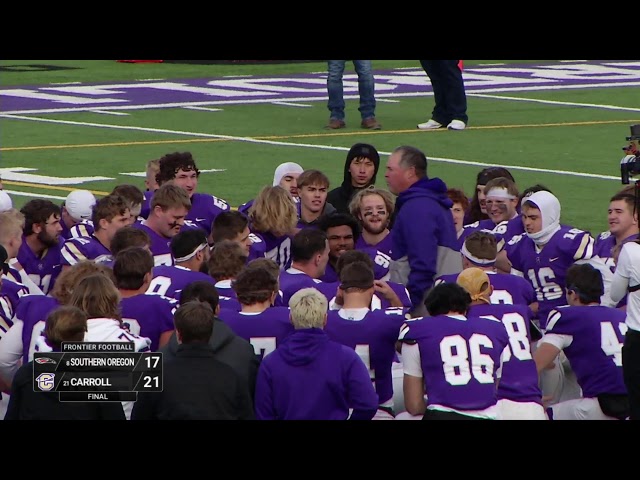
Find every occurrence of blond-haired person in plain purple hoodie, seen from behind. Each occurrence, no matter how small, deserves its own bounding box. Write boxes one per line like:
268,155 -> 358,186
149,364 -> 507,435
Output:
255,288 -> 378,420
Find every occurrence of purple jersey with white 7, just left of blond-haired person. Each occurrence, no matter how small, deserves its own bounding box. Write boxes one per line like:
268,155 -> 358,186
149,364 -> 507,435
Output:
219,307 -> 293,357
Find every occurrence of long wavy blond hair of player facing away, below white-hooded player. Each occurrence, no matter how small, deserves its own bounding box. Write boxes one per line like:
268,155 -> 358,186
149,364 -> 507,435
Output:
249,186 -> 298,237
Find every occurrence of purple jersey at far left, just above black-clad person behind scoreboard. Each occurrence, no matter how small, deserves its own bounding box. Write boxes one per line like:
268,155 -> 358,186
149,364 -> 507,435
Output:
15,295 -> 60,363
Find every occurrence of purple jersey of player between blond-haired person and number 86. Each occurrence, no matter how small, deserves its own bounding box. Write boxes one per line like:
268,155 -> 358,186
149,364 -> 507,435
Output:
324,308 -> 405,405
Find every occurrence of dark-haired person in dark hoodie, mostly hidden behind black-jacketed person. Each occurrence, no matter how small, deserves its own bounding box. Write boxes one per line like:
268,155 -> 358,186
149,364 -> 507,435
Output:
160,280 -> 260,399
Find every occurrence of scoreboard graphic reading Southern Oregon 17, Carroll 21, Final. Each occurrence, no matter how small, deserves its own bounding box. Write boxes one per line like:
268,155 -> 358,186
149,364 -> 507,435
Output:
33,342 -> 162,402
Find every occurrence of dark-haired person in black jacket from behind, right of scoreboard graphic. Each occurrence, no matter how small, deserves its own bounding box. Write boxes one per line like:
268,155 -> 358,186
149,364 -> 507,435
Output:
131,301 -> 255,420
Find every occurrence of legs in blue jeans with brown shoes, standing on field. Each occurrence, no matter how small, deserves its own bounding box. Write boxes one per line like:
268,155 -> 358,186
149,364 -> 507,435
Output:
326,60 -> 382,130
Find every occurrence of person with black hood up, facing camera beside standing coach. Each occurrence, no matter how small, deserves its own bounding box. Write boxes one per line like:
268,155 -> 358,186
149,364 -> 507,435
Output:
327,143 -> 380,213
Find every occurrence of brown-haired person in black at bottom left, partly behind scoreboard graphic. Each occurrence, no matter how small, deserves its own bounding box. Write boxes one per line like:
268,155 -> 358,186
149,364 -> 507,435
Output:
4,306 -> 126,420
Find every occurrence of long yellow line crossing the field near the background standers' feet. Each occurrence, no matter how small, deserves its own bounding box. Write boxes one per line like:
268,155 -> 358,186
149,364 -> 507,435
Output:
0,119 -> 638,152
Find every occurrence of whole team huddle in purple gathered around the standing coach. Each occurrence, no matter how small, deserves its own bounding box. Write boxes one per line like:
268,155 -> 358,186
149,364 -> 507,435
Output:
0,143 -> 638,420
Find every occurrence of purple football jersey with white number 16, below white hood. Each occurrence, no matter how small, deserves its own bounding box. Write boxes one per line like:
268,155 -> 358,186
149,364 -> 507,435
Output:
505,226 -> 594,328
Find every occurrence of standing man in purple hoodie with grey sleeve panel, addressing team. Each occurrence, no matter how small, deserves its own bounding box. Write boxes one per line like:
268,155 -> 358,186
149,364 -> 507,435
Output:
385,146 -> 462,316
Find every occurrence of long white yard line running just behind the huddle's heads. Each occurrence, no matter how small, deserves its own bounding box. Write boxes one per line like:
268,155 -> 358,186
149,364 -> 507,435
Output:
0,114 -> 620,182
